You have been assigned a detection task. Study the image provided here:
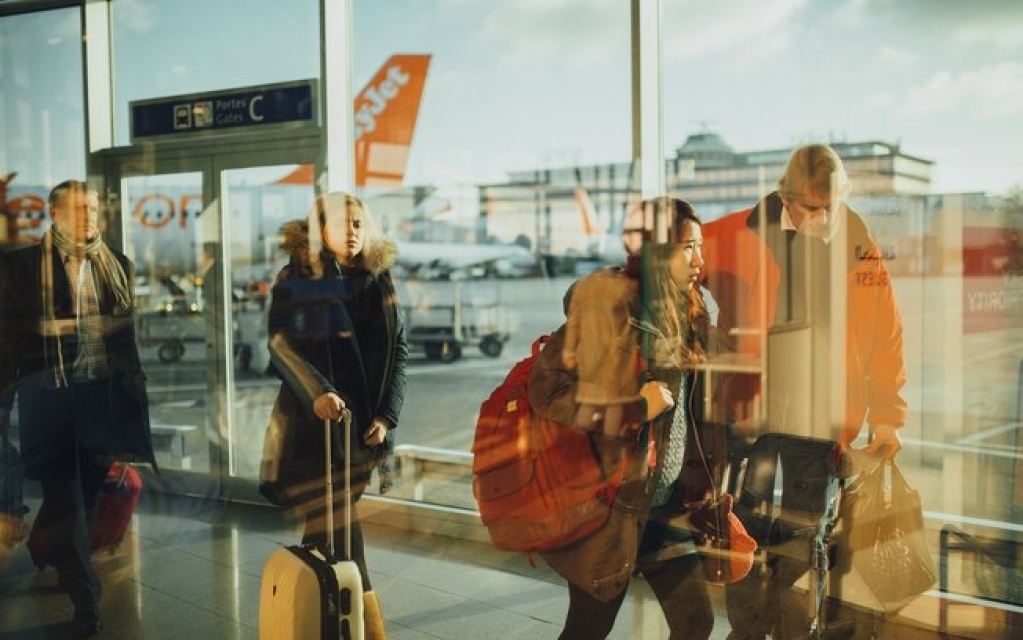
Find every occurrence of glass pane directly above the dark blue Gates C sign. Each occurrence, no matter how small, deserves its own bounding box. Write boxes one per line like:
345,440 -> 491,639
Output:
113,0 -> 320,146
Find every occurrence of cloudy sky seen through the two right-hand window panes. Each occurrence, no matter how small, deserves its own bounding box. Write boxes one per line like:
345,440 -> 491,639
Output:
355,0 -> 1023,192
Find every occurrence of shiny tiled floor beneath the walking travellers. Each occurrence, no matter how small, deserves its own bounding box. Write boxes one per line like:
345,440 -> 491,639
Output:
0,493 -> 1009,640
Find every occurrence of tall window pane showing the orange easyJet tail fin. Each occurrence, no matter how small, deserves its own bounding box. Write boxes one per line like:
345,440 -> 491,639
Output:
353,0 -> 637,509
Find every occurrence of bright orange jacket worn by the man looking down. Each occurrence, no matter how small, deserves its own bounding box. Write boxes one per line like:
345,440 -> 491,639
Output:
703,193 -> 906,445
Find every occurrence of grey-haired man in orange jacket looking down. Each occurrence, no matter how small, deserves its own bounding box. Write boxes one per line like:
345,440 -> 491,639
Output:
703,144 -> 906,638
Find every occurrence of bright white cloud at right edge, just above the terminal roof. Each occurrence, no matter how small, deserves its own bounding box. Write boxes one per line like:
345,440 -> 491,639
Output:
898,62 -> 1023,118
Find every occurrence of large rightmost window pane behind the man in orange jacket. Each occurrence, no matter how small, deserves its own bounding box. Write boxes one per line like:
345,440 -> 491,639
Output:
664,0 -> 1023,617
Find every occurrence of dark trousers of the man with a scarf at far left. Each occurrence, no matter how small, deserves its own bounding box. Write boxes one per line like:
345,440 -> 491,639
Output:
18,380 -> 108,607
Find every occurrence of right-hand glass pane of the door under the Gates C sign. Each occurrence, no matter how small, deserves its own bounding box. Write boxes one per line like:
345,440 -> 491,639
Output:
221,165 -> 314,481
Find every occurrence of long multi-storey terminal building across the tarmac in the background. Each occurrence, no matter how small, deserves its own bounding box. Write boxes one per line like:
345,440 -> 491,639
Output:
474,131 -> 933,272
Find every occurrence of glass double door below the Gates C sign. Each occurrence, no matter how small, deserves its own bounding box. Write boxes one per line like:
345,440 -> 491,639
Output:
103,136 -> 318,499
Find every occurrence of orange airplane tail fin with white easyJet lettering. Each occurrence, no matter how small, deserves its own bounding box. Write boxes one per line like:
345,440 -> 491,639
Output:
354,54 -> 431,187
